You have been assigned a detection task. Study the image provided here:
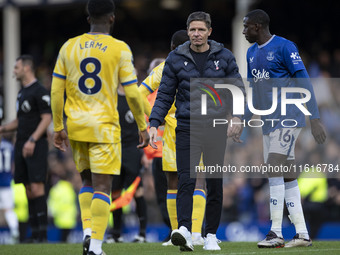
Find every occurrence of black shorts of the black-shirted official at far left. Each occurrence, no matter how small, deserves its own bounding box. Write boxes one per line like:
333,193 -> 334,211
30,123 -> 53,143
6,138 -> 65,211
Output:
14,139 -> 48,184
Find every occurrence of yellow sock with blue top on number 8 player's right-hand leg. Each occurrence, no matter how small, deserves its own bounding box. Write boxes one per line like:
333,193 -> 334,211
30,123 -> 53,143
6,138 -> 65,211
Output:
91,191 -> 111,240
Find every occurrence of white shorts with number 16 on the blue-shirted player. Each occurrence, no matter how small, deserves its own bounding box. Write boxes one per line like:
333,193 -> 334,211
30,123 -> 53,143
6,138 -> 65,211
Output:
263,128 -> 301,163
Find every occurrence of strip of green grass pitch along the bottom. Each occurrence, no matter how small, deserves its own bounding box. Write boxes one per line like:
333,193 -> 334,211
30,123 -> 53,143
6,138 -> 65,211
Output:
0,241 -> 340,255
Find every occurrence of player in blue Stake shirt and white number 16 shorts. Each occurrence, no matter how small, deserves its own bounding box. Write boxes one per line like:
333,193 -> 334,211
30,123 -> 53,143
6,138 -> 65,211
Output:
243,10 -> 326,248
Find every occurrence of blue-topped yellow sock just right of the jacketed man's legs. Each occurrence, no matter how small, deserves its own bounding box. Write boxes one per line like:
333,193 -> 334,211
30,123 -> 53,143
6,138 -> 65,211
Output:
192,189 -> 206,233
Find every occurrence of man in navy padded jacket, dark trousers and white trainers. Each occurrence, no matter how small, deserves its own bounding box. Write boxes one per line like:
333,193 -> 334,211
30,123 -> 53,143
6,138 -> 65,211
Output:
150,12 -> 244,251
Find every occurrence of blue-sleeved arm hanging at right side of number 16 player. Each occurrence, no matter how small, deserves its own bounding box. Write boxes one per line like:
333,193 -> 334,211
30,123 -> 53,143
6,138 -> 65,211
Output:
293,69 -> 326,144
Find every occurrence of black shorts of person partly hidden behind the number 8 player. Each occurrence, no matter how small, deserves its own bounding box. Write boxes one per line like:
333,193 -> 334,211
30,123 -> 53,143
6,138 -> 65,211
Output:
112,145 -> 142,191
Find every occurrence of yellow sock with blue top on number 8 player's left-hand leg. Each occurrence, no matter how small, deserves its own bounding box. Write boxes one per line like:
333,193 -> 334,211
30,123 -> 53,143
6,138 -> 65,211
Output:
78,186 -> 93,230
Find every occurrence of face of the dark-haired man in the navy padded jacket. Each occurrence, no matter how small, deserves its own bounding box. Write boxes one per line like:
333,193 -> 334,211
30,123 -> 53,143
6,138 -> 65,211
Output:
188,21 -> 212,47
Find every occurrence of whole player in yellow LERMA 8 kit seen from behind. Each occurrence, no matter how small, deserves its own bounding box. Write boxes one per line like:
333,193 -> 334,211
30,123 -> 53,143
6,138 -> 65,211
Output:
51,0 -> 149,254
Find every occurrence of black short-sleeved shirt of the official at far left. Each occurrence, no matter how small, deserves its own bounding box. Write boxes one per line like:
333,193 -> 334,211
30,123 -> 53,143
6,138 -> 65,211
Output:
16,81 -> 51,140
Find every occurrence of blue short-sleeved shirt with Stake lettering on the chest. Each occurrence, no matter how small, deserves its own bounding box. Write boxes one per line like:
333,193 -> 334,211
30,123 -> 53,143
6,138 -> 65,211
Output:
247,35 -> 305,134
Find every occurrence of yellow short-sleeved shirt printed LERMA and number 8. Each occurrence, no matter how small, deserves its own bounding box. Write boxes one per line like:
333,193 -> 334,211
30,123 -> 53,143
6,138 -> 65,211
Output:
53,33 -> 137,143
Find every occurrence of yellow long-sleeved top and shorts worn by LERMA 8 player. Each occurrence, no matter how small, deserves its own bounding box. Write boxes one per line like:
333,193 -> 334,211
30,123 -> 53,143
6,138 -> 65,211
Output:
52,33 -> 146,174
